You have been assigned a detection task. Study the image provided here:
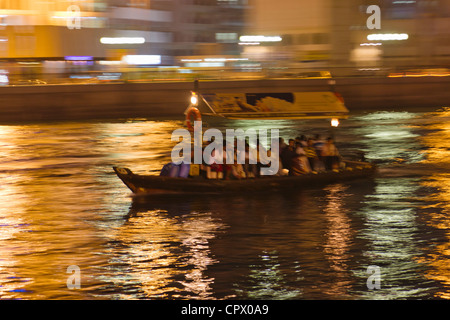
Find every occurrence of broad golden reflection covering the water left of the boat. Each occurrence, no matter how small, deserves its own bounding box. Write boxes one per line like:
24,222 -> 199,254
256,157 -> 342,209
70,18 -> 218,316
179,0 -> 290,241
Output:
0,121 -> 180,299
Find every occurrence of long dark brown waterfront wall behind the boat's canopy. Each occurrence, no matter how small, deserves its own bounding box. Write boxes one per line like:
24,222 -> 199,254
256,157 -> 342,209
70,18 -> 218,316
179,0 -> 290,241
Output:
0,77 -> 450,123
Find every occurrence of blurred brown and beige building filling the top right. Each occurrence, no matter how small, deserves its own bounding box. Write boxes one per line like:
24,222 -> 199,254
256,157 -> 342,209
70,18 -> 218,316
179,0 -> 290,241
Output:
244,0 -> 450,72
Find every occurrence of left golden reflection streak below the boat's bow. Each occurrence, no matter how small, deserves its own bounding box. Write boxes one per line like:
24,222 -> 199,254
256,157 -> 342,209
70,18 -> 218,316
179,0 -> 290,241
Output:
104,212 -> 184,298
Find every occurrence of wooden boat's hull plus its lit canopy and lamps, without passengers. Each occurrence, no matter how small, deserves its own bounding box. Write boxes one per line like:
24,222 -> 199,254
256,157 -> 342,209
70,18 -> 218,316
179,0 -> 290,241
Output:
114,92 -> 376,195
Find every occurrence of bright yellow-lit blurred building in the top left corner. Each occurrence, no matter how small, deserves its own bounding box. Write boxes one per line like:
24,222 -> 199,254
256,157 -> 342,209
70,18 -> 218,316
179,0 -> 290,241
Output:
0,0 -> 107,59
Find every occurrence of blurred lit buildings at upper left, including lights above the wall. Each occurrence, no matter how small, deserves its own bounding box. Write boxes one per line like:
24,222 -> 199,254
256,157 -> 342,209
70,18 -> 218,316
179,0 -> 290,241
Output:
0,0 -> 246,85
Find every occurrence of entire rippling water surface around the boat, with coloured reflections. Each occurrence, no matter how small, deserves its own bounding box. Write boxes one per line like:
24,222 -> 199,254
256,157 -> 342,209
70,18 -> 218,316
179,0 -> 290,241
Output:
0,109 -> 450,300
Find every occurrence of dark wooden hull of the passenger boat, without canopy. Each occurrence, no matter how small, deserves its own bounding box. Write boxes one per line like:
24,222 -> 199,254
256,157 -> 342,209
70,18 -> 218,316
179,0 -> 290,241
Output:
113,161 -> 376,195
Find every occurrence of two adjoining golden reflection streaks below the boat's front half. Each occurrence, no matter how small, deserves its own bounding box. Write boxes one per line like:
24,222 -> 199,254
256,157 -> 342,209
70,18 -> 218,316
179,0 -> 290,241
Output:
103,210 -> 222,299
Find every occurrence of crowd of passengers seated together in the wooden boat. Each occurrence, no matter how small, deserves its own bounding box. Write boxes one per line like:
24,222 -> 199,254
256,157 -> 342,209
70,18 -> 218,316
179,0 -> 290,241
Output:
201,135 -> 340,179
